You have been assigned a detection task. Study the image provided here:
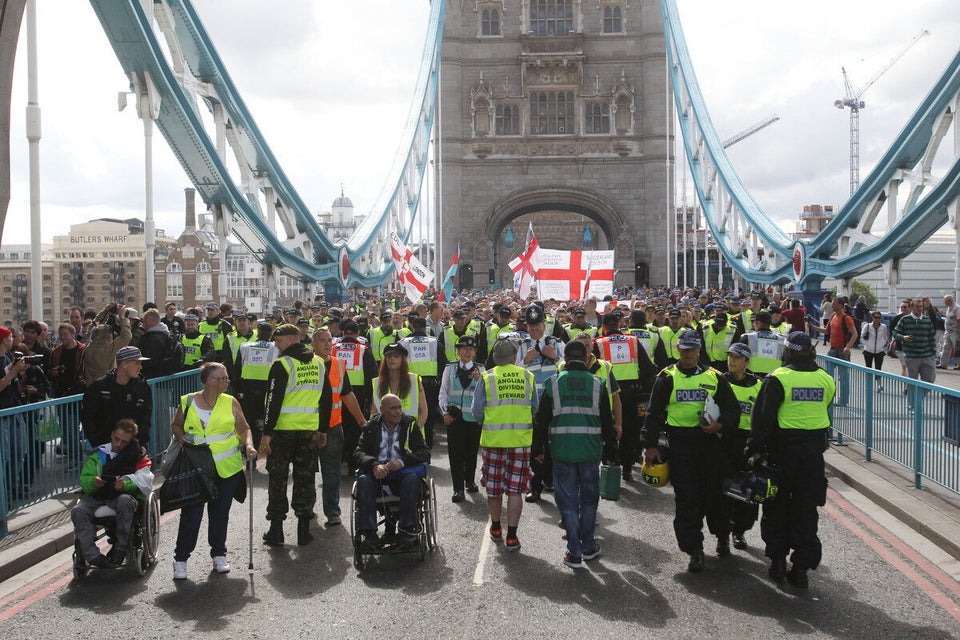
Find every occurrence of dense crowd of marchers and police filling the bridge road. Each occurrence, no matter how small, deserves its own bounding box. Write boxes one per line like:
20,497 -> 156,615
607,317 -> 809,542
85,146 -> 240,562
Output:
0,289 -> 960,587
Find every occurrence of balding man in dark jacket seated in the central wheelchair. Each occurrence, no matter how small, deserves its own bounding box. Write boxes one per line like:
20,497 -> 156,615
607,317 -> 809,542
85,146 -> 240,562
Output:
353,393 -> 430,552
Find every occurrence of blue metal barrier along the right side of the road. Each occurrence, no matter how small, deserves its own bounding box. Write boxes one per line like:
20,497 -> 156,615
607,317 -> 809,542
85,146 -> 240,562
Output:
817,356 -> 960,493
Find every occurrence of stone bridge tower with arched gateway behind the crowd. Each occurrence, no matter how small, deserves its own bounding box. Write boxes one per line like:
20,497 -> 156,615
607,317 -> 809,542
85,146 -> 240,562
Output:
438,0 -> 673,287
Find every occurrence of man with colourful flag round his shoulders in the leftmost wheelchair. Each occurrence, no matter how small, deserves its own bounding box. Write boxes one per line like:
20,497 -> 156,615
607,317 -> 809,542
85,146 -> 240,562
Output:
70,418 -> 153,569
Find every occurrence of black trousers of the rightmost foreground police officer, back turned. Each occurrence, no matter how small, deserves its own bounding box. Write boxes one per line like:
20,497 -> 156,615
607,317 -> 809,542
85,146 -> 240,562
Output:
760,431 -> 827,569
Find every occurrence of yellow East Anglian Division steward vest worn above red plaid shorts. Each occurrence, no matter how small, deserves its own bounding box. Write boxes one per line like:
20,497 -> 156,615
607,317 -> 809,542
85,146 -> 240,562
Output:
480,364 -> 537,449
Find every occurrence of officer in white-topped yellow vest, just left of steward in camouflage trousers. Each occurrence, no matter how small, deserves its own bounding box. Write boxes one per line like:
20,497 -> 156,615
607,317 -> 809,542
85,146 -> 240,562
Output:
233,322 -> 280,449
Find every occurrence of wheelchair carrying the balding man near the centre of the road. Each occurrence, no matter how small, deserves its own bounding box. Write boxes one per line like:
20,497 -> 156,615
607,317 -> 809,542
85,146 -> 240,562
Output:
350,476 -> 439,571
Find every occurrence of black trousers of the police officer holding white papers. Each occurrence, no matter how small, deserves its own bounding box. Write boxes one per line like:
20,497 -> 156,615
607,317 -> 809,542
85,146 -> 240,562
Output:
670,427 -> 730,553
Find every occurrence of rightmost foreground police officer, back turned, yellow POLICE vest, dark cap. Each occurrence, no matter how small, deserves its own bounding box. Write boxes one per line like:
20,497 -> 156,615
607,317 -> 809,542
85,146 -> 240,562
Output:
749,331 -> 837,589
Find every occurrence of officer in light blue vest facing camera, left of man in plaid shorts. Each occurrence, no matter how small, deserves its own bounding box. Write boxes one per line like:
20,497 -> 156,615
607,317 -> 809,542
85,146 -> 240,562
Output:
438,328 -> 484,503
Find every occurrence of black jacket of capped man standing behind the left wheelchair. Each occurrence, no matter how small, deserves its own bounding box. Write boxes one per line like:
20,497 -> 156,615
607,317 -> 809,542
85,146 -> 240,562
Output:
80,369 -> 153,449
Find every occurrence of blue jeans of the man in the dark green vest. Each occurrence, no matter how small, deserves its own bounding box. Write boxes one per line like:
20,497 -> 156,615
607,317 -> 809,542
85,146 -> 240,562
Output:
553,460 -> 600,558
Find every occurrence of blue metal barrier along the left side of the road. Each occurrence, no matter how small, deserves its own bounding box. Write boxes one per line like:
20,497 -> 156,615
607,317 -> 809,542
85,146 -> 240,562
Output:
0,369 -> 200,537
